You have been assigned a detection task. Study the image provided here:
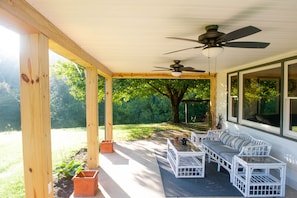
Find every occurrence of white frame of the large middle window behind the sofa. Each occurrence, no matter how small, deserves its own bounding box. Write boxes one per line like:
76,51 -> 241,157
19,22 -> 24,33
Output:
238,63 -> 281,135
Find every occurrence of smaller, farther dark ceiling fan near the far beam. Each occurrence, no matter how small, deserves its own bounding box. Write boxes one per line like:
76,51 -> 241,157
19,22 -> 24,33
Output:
154,60 -> 205,77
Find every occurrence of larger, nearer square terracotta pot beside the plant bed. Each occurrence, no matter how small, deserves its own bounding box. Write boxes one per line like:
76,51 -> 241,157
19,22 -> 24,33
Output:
72,170 -> 99,197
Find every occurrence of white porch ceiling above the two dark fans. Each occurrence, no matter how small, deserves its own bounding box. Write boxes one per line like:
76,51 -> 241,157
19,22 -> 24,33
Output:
27,0 -> 297,73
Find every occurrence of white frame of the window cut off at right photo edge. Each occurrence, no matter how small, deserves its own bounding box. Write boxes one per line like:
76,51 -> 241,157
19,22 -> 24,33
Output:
283,60 -> 297,139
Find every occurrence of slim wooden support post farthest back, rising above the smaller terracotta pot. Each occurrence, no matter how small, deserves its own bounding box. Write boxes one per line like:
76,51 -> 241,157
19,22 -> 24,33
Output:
105,78 -> 113,140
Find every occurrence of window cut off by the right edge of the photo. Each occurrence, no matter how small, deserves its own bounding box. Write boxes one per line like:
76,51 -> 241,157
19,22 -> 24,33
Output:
284,60 -> 297,138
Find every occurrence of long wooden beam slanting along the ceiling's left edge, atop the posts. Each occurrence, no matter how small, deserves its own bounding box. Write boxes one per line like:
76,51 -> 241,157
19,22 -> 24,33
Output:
0,0 -> 112,76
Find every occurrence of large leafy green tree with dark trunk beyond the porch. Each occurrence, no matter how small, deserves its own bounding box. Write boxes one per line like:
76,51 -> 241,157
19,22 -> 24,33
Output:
54,62 -> 210,123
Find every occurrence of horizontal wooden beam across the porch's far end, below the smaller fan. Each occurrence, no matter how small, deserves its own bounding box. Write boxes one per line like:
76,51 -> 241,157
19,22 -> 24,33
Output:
112,72 -> 215,79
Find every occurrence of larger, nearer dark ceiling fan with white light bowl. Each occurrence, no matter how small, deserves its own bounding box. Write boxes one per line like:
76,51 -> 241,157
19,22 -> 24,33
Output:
165,25 -> 270,57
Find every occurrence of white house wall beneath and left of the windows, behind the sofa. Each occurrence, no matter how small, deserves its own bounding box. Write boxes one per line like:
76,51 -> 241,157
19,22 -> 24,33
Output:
216,67 -> 297,190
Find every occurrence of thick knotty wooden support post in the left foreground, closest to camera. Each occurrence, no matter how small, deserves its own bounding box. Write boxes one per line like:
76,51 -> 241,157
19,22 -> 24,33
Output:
20,34 -> 53,198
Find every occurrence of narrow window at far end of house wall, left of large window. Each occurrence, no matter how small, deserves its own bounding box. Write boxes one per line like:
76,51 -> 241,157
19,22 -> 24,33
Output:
228,73 -> 238,122
